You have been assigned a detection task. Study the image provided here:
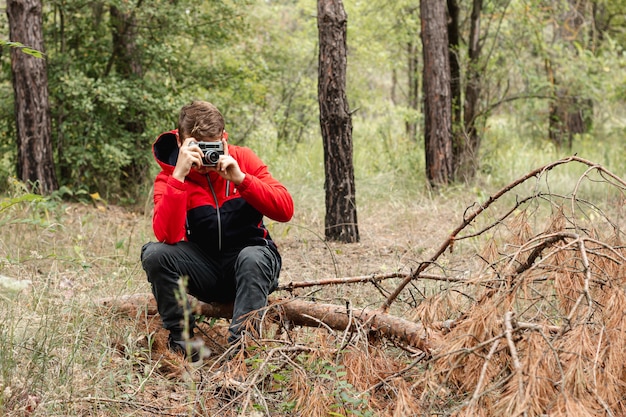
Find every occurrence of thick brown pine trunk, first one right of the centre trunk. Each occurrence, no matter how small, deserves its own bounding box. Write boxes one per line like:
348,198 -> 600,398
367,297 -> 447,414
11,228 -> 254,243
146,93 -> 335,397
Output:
420,0 -> 453,187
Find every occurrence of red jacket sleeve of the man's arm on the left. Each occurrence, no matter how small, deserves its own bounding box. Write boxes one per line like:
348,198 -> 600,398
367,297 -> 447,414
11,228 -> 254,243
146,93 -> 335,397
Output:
152,172 -> 187,244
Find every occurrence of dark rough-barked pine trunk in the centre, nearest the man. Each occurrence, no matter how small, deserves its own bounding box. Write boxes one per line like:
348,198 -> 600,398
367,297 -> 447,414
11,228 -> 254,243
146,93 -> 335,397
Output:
317,0 -> 359,242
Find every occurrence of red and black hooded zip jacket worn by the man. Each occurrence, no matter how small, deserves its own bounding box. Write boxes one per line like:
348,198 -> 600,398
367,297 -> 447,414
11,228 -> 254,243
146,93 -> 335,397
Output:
152,130 -> 293,253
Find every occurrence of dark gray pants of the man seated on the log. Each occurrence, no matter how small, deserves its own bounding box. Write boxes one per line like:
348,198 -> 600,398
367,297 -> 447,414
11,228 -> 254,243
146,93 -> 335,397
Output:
141,241 -> 281,343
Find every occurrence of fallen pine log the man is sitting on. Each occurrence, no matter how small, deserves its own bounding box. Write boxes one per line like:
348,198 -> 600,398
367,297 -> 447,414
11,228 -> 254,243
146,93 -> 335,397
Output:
97,294 -> 433,354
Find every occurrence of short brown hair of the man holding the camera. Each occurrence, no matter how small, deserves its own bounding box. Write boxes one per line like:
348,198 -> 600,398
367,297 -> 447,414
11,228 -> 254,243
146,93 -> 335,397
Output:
178,101 -> 224,141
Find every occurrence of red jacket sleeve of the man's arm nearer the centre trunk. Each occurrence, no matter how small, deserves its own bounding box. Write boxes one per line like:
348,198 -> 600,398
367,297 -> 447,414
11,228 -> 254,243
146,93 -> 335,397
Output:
237,151 -> 293,222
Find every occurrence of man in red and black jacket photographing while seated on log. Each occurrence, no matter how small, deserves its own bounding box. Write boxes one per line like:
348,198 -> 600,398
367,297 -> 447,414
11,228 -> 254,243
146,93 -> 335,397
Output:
141,101 -> 293,361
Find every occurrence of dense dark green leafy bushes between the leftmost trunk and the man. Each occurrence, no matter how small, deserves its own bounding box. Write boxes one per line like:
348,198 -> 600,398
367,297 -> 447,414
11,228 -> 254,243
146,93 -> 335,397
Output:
2,0 -> 254,201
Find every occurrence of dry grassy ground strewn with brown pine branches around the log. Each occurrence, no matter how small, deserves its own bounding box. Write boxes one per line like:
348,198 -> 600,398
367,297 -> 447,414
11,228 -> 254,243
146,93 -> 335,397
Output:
0,157 -> 626,416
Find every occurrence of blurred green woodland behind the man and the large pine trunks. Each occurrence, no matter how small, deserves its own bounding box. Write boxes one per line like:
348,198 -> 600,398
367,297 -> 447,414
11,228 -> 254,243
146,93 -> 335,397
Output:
0,0 -> 626,204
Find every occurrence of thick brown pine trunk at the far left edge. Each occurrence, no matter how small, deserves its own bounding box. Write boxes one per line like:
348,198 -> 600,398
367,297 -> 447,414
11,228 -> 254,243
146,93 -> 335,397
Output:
6,0 -> 59,194
